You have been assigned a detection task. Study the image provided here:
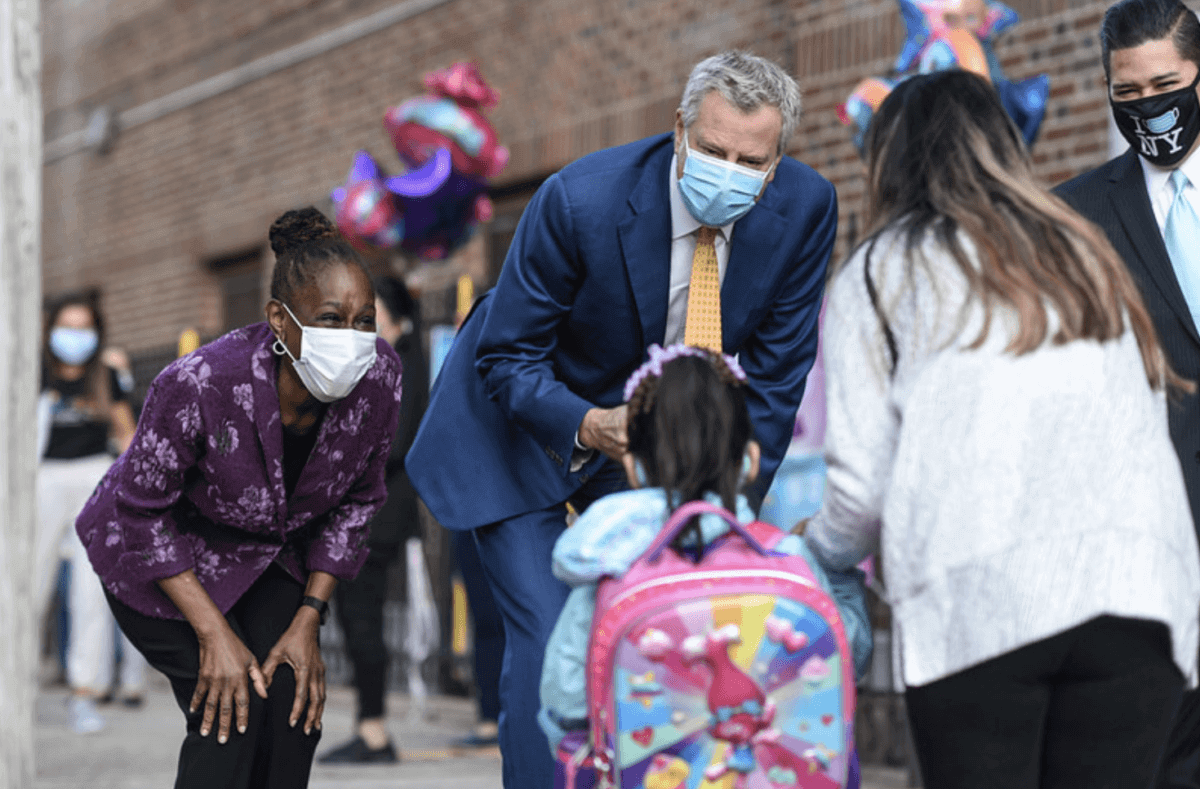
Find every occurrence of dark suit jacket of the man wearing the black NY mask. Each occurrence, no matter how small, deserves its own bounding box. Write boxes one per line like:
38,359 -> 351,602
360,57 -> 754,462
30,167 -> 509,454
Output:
1055,150 -> 1200,520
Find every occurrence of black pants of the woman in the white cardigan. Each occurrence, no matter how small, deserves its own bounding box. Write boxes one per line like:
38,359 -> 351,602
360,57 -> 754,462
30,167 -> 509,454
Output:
905,616 -> 1183,789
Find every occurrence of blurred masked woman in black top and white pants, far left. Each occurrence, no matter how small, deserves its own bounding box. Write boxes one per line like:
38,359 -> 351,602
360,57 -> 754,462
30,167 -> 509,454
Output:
34,291 -> 140,734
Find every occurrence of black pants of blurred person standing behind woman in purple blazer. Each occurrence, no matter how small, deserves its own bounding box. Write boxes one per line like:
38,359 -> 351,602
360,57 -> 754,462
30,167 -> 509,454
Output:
335,547 -> 396,721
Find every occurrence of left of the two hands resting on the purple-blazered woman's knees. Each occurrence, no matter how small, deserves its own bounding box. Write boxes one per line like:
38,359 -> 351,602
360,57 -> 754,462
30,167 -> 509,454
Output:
188,620 -> 269,745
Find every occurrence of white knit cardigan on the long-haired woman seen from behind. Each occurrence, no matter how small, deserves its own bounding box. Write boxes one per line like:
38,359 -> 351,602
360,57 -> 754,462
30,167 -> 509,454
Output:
808,225 -> 1200,686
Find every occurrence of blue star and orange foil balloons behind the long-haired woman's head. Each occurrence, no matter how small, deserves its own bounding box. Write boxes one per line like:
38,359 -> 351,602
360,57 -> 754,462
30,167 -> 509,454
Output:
838,0 -> 1050,152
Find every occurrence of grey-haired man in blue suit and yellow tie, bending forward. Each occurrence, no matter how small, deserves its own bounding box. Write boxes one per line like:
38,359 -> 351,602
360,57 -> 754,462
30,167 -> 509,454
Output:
406,53 -> 838,789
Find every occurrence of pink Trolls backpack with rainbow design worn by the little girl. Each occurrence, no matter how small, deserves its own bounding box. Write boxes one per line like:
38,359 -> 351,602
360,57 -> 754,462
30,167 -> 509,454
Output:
556,501 -> 858,789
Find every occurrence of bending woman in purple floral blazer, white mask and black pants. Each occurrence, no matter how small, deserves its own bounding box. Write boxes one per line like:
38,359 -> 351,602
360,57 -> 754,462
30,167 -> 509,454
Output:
77,209 -> 401,789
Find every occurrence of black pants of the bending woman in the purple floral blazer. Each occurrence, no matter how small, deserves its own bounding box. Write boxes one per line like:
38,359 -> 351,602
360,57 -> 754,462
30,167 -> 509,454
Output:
108,564 -> 320,789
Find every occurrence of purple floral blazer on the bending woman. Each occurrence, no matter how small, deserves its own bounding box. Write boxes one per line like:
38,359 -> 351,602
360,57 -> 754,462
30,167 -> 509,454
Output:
76,323 -> 401,619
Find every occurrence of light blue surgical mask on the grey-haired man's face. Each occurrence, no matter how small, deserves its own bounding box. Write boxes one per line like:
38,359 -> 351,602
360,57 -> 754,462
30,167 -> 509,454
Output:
679,130 -> 770,228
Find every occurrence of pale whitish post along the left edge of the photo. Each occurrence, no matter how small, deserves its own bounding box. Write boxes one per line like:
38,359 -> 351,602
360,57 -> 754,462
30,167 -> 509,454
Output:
0,0 -> 42,789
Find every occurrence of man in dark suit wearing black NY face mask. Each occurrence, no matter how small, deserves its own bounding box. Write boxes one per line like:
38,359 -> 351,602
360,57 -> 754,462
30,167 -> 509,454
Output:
1056,0 -> 1200,789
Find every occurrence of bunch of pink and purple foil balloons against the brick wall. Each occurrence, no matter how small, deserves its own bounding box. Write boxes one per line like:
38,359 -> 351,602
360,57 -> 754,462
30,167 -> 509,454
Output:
332,62 -> 509,259
